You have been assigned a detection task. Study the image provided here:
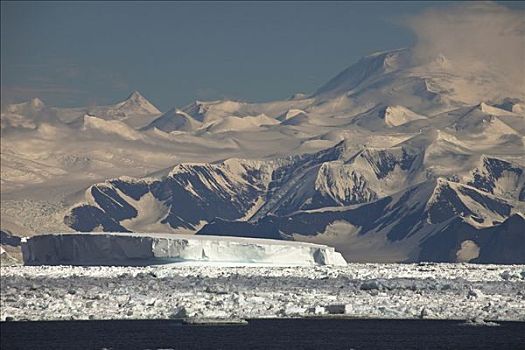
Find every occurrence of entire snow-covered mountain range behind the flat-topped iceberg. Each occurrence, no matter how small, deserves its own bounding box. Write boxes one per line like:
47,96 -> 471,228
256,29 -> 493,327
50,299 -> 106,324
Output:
2,49 -> 525,263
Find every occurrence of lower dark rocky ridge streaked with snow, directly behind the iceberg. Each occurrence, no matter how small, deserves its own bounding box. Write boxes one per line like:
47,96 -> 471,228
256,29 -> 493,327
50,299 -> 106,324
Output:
66,139 -> 525,263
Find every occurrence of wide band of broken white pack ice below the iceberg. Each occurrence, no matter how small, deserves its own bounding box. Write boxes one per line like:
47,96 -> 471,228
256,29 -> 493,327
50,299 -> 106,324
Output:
0,263 -> 525,323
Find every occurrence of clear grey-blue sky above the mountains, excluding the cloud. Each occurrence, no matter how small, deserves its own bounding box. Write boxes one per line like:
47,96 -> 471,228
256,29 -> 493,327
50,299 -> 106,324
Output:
1,1 -> 524,110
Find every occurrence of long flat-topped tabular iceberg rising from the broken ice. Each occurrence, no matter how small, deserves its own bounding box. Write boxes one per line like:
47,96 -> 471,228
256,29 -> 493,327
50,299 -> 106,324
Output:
22,233 -> 346,266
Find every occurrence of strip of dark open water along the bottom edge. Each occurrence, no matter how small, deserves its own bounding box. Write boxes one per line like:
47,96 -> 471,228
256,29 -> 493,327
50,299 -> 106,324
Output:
0,319 -> 525,350
